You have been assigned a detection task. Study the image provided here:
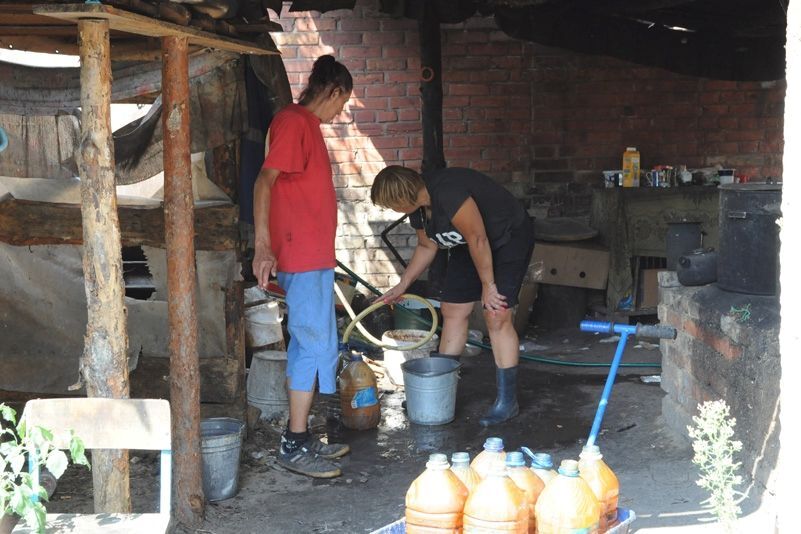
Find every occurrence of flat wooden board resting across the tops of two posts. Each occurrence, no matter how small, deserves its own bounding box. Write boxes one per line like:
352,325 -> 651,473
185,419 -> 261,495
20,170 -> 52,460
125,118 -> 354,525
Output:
33,4 -> 280,55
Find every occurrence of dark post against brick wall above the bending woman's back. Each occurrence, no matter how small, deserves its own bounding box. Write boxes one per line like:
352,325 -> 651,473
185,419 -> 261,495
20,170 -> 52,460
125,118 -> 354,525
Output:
418,2 -> 445,171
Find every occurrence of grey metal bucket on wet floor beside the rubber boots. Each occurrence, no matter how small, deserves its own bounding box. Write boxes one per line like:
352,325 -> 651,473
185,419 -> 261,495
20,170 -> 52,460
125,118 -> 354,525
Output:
401,357 -> 462,425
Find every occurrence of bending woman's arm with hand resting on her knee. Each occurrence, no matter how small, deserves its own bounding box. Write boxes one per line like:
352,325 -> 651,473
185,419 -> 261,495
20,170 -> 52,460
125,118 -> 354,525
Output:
451,198 -> 506,310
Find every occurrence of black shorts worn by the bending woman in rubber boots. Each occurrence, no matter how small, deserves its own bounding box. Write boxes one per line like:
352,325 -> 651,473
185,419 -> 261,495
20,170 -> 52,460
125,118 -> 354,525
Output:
442,221 -> 534,308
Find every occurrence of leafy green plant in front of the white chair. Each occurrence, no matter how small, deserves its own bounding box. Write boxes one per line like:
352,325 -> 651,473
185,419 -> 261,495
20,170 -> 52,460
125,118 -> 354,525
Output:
0,404 -> 89,532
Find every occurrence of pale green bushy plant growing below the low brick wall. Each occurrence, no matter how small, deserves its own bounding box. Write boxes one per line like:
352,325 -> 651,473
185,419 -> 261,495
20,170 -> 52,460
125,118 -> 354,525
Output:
687,400 -> 743,532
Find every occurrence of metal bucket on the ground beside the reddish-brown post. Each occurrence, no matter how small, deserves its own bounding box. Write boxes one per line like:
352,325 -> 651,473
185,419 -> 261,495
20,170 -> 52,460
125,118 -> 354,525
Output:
200,417 -> 245,502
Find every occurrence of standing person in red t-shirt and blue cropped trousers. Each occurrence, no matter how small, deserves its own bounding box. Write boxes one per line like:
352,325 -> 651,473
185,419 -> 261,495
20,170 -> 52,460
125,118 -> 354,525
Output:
253,56 -> 353,478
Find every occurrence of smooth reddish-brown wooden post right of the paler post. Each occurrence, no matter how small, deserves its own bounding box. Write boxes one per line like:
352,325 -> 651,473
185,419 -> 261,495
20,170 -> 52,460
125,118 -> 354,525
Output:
161,37 -> 205,527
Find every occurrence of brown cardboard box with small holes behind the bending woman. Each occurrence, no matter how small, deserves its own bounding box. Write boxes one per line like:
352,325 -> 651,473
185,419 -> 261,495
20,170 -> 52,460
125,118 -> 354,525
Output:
528,242 -> 609,289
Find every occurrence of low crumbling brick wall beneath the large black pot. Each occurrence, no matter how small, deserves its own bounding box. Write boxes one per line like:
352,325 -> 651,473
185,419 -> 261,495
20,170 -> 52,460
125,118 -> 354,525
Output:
659,272 -> 781,496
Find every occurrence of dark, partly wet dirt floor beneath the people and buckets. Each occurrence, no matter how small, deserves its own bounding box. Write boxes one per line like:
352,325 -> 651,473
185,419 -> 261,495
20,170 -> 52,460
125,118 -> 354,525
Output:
34,329 -> 772,534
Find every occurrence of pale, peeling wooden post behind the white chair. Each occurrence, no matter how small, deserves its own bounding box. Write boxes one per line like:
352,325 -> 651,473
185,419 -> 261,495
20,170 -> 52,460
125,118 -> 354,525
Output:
78,19 -> 131,513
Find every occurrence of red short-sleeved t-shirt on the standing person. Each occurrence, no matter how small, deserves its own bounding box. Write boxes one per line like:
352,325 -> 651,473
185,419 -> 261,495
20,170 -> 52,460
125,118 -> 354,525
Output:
262,104 -> 337,273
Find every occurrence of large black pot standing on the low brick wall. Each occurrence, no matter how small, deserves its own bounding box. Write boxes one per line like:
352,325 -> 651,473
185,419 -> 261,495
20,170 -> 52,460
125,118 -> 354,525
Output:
718,183 -> 782,295
